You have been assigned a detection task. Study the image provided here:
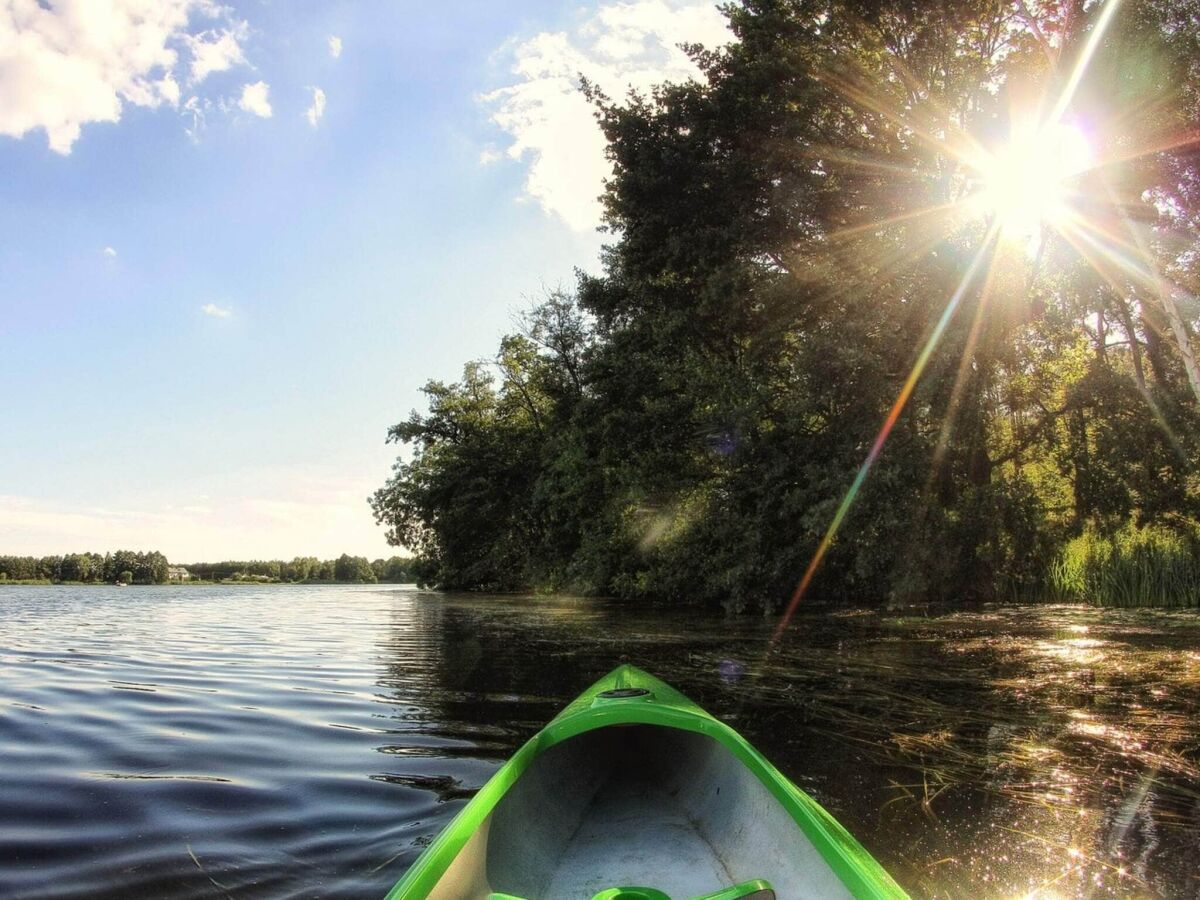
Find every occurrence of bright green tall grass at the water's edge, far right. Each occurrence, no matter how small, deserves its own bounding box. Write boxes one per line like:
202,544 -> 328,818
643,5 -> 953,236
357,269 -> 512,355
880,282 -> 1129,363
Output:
1048,523 -> 1200,607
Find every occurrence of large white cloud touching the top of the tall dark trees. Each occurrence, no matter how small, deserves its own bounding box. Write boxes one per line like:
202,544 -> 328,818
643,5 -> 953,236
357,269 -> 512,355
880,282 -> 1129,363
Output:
480,0 -> 731,230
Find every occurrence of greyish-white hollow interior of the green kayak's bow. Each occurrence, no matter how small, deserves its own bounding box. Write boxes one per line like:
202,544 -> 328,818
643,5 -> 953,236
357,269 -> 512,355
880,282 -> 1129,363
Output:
431,725 -> 850,900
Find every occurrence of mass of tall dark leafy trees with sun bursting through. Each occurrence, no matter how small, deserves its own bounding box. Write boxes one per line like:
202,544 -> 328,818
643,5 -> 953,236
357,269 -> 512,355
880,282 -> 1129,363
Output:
372,0 -> 1200,610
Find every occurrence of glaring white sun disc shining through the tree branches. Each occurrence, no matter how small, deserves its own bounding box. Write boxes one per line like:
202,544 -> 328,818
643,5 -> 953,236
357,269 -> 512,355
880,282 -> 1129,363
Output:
976,124 -> 1093,240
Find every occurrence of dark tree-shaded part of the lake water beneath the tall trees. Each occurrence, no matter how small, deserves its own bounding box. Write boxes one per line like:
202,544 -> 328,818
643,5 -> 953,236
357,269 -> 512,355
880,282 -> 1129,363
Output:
379,594 -> 1200,896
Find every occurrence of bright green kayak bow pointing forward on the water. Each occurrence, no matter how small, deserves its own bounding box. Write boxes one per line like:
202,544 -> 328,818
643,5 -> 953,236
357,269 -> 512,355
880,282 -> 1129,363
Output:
388,666 -> 905,900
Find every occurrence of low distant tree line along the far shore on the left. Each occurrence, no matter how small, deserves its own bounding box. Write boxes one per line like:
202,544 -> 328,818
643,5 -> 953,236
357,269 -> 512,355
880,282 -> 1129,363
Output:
0,550 -> 415,584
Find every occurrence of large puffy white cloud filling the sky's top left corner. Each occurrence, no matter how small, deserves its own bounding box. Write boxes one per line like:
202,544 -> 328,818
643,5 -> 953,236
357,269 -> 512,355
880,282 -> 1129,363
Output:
0,0 -> 247,154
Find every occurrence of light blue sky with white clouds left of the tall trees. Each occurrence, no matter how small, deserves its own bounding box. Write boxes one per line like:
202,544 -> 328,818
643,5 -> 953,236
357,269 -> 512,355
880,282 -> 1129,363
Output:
0,0 -> 724,562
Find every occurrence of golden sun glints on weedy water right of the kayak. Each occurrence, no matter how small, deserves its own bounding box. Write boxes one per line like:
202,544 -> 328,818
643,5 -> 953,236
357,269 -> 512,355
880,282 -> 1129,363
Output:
768,607 -> 1200,898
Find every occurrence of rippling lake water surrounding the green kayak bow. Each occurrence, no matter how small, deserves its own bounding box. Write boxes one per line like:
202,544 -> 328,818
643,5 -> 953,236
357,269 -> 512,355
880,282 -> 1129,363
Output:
0,586 -> 1200,898
